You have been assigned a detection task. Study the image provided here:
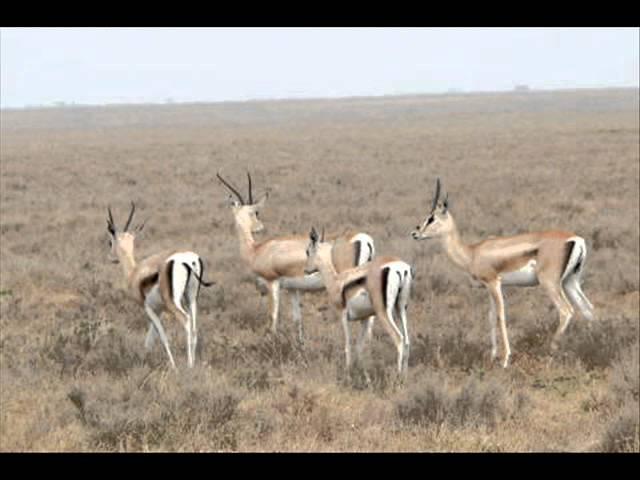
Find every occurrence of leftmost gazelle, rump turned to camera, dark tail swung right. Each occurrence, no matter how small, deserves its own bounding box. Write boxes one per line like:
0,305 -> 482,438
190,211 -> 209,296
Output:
107,202 -> 213,369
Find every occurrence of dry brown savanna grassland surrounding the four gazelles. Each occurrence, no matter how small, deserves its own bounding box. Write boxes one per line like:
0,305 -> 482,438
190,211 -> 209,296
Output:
0,89 -> 640,452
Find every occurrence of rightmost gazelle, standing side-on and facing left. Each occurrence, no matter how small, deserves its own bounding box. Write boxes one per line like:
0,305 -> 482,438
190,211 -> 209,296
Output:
411,178 -> 593,368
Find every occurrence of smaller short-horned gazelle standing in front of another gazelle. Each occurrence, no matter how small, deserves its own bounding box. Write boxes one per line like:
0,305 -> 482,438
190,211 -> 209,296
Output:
304,228 -> 413,374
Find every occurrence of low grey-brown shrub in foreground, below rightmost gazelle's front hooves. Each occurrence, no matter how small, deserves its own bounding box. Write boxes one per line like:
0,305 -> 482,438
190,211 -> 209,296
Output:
396,378 -> 529,428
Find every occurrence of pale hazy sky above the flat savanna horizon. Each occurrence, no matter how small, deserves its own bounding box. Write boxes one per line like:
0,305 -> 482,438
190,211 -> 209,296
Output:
0,28 -> 640,108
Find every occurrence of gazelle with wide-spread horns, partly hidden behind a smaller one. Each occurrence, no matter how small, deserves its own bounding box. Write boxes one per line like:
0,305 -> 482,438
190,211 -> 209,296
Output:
217,172 -> 375,343
